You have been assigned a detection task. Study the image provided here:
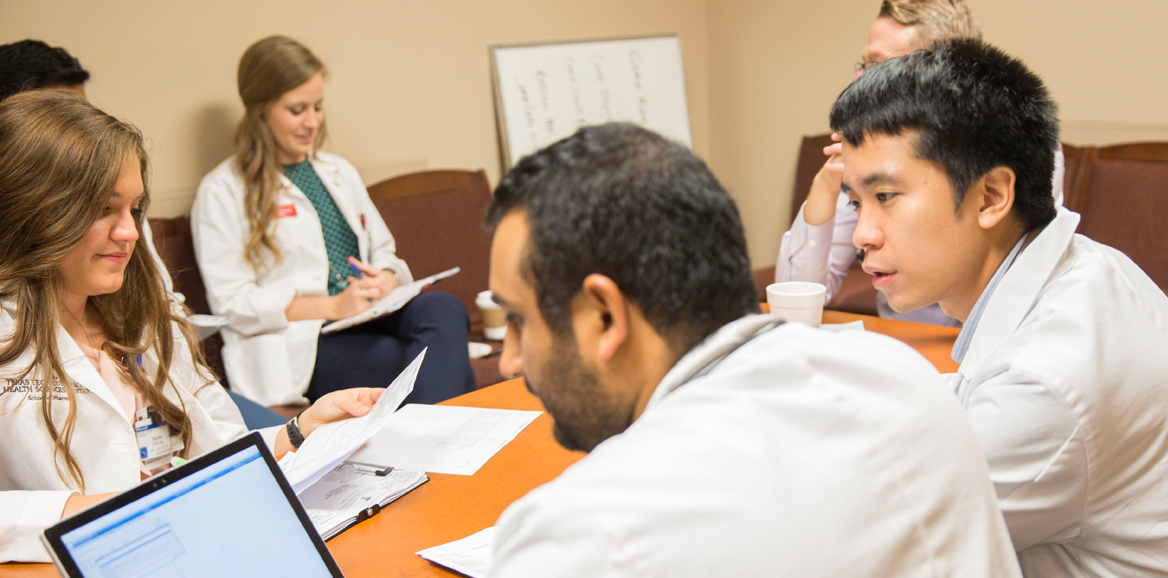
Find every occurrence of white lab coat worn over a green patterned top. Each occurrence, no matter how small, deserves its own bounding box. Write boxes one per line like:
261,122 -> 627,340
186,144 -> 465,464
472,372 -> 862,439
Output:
190,153 -> 413,405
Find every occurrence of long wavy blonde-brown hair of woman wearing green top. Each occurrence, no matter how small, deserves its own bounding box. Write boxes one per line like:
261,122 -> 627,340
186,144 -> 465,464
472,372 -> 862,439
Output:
235,36 -> 327,271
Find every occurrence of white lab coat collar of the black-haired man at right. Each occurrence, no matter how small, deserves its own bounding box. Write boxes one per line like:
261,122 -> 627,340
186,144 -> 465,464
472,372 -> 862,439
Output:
958,207 -> 1079,379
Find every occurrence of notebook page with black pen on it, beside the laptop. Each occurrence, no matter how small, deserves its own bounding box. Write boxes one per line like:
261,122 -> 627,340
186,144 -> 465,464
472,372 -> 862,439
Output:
298,464 -> 427,539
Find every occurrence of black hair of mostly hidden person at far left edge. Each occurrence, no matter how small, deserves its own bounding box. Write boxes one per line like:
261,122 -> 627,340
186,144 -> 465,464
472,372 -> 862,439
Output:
0,40 -> 89,100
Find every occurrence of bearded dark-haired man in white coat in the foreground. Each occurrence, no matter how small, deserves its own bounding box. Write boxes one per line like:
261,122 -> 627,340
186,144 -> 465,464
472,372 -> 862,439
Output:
487,124 -> 1018,578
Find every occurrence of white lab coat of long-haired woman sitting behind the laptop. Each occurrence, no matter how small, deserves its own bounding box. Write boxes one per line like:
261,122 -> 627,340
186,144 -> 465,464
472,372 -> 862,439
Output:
0,305 -> 253,562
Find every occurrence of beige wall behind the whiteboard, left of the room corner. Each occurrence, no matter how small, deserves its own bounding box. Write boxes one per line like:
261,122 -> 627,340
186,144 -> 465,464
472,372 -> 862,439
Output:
0,0 -> 709,216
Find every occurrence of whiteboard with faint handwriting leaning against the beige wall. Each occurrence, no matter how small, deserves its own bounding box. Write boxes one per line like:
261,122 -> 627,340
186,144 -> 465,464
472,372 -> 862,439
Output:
491,35 -> 693,170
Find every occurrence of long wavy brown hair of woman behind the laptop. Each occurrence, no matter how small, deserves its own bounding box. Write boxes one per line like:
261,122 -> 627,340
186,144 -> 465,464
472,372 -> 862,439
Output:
0,90 -> 214,493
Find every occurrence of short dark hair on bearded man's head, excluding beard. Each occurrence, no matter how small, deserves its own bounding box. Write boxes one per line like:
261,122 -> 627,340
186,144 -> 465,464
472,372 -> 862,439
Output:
486,123 -> 758,353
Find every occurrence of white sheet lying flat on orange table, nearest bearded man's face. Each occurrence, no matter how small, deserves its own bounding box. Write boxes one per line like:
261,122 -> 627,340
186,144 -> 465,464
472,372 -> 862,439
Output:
352,404 -> 541,475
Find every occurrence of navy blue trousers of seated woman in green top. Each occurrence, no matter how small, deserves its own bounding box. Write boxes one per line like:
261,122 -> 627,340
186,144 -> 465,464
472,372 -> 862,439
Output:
306,292 -> 474,404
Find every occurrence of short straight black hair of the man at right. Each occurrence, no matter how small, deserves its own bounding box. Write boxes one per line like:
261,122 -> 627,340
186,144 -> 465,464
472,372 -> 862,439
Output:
832,39 -> 1059,230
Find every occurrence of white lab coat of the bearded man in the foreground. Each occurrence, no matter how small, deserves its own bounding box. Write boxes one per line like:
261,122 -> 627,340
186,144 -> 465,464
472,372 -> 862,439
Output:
491,315 -> 1020,578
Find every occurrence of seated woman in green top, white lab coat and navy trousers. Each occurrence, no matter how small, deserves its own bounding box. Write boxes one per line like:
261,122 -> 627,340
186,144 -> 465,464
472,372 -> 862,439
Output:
190,36 -> 474,405
